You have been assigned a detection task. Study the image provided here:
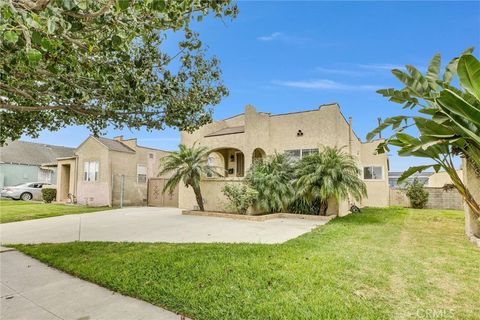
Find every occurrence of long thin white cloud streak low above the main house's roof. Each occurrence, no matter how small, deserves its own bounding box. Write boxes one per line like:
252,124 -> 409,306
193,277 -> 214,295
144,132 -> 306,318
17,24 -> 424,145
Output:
274,79 -> 380,91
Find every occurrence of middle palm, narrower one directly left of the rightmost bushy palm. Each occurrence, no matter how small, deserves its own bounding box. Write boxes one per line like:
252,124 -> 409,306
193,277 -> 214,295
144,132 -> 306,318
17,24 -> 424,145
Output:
246,153 -> 294,212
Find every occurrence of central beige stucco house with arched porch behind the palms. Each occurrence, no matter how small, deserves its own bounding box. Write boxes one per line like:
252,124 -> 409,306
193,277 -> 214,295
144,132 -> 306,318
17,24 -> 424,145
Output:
179,103 -> 389,214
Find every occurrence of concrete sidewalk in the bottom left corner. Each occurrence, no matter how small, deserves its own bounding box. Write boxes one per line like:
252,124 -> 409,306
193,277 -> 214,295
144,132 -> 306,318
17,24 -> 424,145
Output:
0,248 -> 185,320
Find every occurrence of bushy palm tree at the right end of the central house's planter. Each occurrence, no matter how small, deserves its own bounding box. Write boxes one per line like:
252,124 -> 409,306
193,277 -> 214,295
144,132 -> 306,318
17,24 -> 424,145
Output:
295,147 -> 367,215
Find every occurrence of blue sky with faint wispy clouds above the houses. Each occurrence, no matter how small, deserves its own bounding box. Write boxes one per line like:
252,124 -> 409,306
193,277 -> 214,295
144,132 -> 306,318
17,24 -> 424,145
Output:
22,1 -> 480,171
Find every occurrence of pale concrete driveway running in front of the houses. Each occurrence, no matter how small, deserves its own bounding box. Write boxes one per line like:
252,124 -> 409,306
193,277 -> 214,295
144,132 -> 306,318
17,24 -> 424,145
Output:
0,207 -> 326,244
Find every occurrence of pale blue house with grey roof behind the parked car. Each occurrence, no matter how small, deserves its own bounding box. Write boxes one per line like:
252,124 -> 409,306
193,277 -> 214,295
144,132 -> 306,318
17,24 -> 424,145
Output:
0,141 -> 75,187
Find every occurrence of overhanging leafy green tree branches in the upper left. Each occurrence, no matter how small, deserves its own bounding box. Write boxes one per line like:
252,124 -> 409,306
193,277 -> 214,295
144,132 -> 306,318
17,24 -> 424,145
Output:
0,0 -> 237,143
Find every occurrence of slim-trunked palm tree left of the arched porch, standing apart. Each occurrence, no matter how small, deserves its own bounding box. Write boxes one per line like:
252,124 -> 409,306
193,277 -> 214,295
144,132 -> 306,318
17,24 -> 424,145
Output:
158,144 -> 221,211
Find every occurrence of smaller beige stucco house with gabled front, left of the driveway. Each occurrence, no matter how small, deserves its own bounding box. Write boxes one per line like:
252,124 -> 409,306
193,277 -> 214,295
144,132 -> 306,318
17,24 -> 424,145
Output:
57,136 -> 177,206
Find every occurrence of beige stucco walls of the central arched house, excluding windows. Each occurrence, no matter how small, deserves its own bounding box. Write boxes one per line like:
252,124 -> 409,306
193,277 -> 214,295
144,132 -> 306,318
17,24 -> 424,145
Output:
179,104 -> 389,214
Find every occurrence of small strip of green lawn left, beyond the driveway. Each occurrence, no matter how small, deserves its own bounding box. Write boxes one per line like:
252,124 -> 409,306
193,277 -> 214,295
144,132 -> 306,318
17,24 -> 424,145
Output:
0,199 -> 111,223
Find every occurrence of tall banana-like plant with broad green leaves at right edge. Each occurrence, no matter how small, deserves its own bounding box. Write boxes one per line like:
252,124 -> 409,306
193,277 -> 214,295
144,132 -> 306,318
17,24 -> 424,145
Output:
367,48 -> 480,219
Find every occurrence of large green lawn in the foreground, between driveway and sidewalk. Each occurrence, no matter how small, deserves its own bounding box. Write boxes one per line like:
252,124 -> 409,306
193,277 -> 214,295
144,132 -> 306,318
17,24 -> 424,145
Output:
12,208 -> 480,320
